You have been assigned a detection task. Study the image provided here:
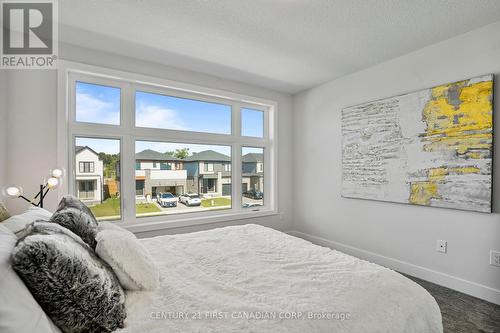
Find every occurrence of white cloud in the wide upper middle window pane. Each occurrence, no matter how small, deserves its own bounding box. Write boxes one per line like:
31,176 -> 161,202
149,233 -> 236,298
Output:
136,104 -> 189,130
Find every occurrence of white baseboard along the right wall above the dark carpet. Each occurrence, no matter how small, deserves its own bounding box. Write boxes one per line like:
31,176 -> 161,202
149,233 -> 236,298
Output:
288,230 -> 500,305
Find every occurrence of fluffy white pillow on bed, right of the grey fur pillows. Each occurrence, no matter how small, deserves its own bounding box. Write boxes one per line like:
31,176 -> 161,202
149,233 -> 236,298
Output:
95,227 -> 160,290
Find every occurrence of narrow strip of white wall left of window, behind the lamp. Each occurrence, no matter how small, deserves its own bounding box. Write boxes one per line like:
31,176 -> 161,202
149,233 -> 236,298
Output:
6,70 -> 57,214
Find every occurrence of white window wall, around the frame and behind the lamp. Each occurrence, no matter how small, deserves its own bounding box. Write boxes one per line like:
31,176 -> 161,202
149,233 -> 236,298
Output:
3,44 -> 292,236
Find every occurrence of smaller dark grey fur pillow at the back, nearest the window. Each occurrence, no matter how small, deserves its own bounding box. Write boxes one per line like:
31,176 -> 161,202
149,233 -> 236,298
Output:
50,207 -> 97,249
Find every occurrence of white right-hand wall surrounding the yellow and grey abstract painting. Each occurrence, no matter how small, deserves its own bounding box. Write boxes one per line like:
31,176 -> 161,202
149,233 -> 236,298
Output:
293,22 -> 500,303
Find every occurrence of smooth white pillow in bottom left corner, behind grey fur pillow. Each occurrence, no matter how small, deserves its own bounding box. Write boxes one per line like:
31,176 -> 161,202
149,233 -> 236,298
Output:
0,223 -> 61,333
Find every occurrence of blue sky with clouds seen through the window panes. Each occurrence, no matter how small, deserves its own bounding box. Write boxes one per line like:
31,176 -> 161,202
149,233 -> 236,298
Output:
76,82 -> 264,156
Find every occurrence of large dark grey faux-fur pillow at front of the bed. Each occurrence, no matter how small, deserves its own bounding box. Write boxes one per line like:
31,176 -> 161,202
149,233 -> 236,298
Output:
12,222 -> 126,333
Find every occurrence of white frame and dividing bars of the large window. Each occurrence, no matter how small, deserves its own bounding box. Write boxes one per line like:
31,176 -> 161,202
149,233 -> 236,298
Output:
57,60 -> 278,232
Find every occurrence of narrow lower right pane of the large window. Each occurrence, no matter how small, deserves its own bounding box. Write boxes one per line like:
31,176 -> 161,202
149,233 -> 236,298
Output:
241,147 -> 265,209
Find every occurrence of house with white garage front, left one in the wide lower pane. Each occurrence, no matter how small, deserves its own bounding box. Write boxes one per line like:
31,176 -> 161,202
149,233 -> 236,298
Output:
135,149 -> 187,198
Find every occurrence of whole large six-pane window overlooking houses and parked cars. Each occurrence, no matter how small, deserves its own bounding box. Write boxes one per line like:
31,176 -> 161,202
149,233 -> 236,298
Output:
64,64 -> 277,230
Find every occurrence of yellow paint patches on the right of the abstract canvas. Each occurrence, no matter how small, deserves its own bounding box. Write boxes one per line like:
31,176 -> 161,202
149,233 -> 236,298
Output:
409,80 -> 493,205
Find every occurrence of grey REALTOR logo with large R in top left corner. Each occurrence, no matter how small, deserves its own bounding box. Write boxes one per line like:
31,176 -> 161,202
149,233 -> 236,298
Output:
0,1 -> 57,69
